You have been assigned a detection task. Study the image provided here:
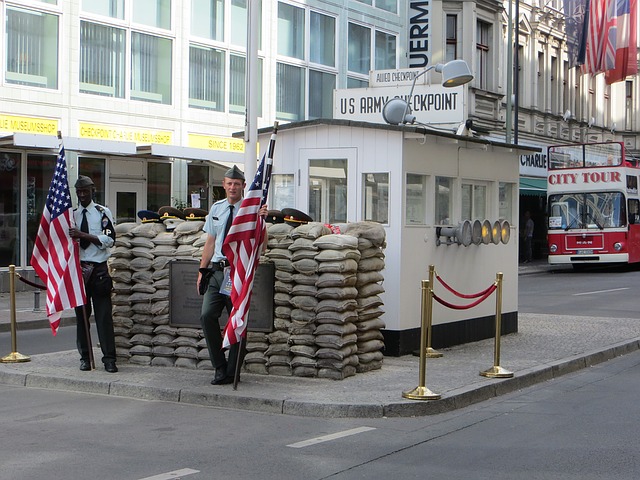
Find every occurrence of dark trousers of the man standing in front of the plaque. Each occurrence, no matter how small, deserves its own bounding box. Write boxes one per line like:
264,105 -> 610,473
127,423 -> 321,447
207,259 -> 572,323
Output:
200,270 -> 239,376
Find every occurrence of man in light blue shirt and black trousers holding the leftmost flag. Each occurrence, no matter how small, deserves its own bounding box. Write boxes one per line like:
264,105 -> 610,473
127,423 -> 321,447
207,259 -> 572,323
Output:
69,175 -> 118,373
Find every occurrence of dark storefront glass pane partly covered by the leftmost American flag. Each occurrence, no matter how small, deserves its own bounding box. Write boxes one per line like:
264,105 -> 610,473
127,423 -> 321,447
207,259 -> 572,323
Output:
26,154 -> 56,263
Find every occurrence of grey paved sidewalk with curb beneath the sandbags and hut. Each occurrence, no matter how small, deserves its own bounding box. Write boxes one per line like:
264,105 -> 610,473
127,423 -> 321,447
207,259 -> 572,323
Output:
0,264 -> 640,418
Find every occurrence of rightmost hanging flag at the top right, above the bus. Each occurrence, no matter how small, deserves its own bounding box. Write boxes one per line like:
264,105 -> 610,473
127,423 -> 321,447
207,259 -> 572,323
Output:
605,0 -> 638,85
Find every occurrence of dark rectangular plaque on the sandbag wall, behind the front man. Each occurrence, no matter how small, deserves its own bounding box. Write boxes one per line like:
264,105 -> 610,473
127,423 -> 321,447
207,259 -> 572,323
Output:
169,259 -> 275,332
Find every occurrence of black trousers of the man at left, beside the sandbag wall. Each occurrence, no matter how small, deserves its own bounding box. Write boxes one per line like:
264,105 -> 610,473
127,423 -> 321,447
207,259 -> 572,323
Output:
75,263 -> 116,363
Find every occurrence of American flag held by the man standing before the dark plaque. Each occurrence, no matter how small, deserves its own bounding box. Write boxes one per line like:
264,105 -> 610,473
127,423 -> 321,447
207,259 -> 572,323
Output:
222,129 -> 277,348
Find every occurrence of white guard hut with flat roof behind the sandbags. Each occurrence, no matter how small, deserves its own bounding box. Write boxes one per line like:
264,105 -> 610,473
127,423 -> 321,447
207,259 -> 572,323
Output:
252,119 -> 539,355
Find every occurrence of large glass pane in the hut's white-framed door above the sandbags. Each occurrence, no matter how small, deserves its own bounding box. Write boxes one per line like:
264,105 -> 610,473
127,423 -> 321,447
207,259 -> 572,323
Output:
309,158 -> 347,223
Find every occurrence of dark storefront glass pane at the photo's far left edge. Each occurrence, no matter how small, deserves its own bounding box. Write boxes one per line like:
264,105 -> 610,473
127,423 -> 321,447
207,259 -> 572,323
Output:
0,152 -> 21,267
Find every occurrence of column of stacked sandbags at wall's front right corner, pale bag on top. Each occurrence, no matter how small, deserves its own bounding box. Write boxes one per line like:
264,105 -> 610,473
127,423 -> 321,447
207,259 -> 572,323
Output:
313,234 -> 360,380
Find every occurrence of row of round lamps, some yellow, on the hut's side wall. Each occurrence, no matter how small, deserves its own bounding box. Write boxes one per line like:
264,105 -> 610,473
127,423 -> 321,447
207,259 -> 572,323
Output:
436,220 -> 511,247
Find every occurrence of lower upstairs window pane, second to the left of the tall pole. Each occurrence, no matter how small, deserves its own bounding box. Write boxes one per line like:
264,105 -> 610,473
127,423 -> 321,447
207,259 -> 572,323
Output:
189,45 -> 225,112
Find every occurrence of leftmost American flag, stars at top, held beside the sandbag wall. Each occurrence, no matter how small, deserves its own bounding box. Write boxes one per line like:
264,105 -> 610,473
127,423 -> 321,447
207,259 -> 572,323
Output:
31,145 -> 86,335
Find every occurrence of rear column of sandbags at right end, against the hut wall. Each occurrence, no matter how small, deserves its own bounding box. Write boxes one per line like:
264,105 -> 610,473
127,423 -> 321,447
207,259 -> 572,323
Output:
343,222 -> 386,372
